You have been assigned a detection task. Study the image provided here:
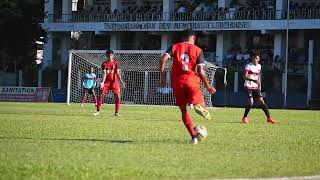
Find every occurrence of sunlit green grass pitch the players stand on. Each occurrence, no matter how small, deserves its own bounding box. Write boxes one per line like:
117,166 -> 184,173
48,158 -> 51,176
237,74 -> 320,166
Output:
0,103 -> 320,179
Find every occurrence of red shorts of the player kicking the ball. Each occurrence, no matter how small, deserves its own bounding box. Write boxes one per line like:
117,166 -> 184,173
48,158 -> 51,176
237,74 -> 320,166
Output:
173,85 -> 204,106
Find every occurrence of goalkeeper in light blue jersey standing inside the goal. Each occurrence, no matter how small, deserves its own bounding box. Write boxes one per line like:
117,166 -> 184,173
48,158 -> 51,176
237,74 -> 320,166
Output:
81,67 -> 97,106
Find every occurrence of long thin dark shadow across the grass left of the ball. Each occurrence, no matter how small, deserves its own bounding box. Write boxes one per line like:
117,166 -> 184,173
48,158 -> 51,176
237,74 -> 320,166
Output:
0,137 -> 133,144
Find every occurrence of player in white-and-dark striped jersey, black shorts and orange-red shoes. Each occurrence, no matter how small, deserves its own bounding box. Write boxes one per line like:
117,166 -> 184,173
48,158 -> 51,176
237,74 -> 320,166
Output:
242,53 -> 276,124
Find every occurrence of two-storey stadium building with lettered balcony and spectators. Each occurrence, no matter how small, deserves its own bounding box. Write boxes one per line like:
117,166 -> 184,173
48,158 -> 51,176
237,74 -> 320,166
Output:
42,0 -> 320,108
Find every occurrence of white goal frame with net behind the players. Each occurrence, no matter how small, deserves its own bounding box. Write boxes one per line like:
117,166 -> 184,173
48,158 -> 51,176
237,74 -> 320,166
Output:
67,50 -> 226,107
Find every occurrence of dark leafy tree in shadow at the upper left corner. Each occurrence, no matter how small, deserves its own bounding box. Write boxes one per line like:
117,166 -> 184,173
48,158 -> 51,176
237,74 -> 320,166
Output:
0,0 -> 46,69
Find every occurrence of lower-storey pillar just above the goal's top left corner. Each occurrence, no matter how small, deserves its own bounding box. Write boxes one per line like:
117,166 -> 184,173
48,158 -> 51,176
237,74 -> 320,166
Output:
60,32 -> 71,64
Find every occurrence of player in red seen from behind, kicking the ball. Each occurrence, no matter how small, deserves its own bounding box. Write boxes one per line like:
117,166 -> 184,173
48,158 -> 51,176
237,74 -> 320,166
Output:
160,29 -> 216,144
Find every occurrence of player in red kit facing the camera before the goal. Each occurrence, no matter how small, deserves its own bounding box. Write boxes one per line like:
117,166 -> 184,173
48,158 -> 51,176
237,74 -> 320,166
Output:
93,50 -> 125,116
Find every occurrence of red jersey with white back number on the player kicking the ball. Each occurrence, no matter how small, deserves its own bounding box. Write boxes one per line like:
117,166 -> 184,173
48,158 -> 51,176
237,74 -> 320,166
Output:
166,42 -> 204,88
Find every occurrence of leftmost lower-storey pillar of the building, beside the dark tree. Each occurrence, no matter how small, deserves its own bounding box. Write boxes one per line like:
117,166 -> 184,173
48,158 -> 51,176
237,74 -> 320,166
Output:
42,31 -> 53,68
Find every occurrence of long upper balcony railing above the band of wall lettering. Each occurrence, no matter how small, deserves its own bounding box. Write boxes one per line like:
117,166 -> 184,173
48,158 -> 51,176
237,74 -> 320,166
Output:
48,9 -> 320,23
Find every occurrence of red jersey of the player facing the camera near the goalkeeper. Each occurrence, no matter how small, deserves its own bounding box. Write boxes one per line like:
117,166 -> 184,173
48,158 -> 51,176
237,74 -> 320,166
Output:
101,60 -> 119,84
